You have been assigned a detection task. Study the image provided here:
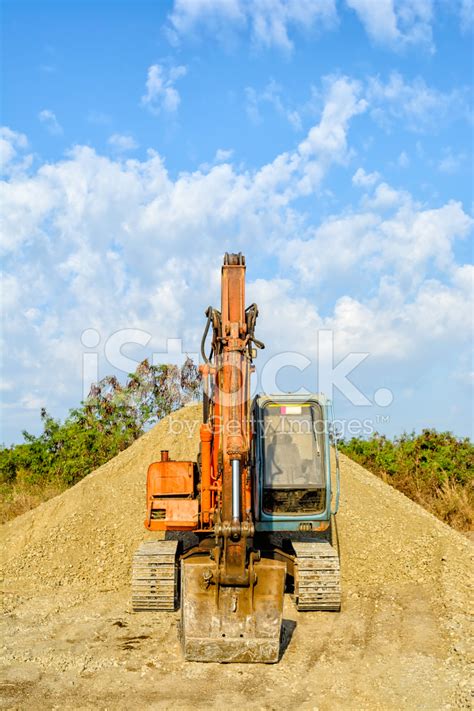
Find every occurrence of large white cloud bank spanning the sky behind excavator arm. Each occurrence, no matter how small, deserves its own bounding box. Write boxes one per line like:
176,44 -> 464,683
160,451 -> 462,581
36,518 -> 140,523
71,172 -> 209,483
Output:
0,72 -> 472,440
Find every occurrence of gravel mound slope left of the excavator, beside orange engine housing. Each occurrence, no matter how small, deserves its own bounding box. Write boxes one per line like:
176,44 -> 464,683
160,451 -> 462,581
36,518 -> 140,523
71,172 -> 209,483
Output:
1,406 -> 201,592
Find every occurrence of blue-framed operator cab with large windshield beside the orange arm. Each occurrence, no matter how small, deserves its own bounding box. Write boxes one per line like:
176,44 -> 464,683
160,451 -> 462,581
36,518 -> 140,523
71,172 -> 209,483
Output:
252,394 -> 339,533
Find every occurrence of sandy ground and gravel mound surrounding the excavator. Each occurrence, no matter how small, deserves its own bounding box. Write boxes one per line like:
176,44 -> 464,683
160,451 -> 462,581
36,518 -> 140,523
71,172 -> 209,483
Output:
0,408 -> 472,711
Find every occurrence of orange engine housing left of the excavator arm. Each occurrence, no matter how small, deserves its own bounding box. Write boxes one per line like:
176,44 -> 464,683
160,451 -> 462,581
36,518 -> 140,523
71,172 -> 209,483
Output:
145,450 -> 199,531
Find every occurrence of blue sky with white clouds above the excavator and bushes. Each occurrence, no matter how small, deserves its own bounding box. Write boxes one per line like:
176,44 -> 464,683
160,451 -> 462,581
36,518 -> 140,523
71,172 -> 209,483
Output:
0,0 -> 473,442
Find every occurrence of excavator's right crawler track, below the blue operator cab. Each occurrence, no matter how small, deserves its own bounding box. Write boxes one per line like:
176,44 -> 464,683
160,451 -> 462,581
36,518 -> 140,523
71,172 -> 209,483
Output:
293,542 -> 341,611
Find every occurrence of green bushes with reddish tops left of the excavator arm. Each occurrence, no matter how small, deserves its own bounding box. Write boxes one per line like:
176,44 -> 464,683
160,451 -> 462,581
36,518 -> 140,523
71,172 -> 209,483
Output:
0,358 -> 200,520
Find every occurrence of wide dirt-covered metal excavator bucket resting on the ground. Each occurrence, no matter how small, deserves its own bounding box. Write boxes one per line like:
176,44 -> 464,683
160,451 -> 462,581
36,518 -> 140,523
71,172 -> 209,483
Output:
181,555 -> 286,663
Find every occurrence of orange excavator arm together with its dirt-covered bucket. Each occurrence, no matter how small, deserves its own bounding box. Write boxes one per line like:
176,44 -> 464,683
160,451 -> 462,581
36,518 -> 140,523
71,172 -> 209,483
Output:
181,254 -> 286,662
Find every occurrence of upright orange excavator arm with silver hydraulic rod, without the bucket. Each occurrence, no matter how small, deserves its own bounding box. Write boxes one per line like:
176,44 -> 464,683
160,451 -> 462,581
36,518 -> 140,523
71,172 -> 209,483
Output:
206,254 -> 254,585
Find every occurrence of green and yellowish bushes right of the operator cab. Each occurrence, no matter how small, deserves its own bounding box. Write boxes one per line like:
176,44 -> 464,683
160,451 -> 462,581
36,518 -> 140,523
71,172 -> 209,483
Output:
340,429 -> 474,531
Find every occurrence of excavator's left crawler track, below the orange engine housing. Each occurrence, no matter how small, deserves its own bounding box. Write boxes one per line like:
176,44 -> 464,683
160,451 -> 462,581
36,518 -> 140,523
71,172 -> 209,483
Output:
132,541 -> 178,612
